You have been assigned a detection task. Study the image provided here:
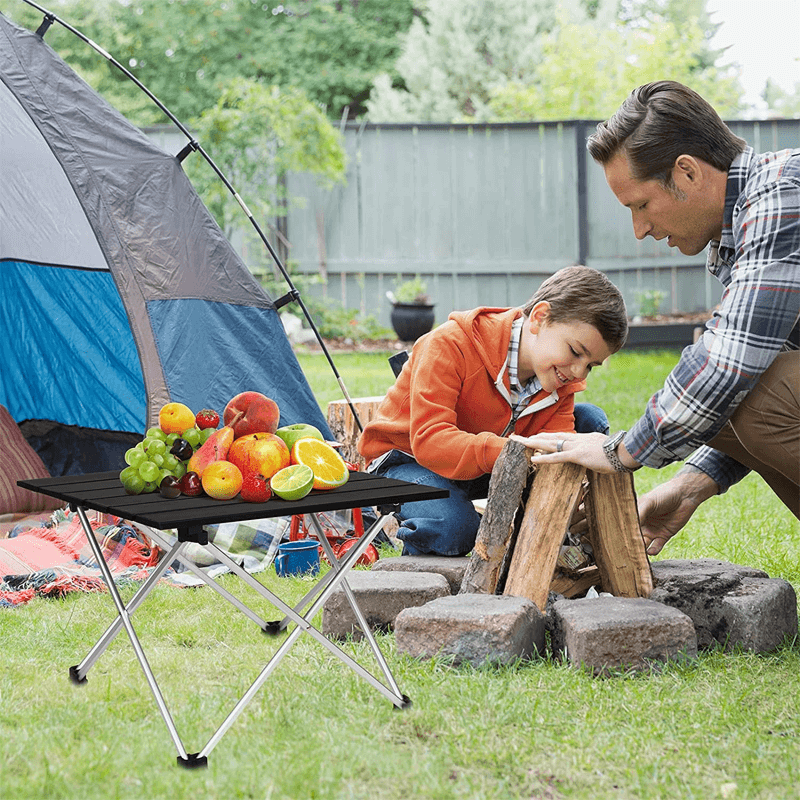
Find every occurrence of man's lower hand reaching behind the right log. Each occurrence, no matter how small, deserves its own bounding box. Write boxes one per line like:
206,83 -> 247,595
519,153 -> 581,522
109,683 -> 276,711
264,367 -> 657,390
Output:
639,466 -> 719,556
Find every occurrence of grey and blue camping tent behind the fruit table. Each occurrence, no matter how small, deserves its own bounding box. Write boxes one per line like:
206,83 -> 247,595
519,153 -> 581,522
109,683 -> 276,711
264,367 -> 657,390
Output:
0,10 -> 332,475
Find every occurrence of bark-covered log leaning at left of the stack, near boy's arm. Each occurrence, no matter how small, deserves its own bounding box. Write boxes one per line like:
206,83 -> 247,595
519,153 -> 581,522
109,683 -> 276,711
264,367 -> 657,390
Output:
460,439 -> 531,594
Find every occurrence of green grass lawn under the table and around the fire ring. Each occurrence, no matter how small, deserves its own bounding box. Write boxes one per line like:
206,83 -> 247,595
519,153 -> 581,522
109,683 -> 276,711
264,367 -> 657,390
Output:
0,354 -> 800,800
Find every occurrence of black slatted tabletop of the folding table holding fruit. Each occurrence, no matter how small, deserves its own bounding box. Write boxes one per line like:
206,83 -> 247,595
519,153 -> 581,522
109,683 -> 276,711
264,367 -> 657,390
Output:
17,471 -> 449,541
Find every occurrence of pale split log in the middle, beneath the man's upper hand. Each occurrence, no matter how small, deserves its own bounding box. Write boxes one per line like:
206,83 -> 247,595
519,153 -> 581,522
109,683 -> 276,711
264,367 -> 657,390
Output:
504,464 -> 586,612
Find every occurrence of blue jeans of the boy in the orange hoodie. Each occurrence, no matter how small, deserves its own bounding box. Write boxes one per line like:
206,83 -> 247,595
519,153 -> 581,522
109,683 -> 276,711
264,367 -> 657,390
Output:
375,403 -> 609,556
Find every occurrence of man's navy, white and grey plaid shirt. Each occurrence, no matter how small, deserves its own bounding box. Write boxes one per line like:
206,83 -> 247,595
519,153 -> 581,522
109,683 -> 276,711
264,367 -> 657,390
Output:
625,148 -> 800,491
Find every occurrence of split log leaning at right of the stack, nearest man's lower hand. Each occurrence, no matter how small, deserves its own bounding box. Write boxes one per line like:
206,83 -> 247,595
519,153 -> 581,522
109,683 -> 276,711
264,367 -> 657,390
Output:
585,472 -> 653,597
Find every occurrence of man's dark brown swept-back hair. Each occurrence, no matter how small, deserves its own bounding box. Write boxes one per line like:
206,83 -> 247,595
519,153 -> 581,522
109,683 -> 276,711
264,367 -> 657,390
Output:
587,81 -> 747,187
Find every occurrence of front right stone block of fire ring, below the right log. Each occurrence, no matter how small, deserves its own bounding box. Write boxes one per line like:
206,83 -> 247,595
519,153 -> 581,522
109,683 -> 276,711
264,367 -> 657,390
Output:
551,597 -> 697,675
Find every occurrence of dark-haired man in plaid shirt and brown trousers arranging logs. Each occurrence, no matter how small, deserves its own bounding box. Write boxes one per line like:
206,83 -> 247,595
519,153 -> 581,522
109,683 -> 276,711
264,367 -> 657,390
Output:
525,81 -> 800,555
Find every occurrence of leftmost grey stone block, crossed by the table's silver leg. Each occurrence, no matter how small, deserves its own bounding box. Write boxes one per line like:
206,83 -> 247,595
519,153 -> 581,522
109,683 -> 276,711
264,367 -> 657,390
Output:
322,570 -> 450,639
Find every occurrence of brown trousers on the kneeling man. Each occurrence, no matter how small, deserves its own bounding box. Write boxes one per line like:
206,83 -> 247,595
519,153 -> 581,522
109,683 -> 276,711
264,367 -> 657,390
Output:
708,350 -> 800,519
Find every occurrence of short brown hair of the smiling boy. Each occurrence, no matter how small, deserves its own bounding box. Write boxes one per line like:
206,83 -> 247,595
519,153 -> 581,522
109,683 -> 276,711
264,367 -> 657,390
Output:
522,266 -> 628,353
